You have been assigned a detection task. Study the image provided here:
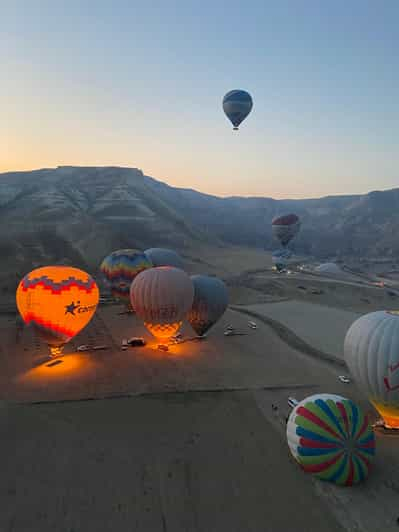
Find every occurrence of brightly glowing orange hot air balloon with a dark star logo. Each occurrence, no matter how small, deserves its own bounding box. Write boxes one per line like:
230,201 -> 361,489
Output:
17,266 -> 99,356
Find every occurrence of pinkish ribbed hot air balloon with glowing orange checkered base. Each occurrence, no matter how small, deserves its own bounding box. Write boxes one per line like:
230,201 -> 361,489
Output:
130,266 -> 194,339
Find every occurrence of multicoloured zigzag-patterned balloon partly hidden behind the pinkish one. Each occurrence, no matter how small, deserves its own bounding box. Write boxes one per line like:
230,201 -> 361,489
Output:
100,249 -> 153,307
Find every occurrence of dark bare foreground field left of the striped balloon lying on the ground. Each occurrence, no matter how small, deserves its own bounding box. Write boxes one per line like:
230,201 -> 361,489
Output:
0,392 -> 343,532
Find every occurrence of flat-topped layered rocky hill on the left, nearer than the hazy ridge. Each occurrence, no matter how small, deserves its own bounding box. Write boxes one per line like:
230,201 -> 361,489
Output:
0,167 -> 212,285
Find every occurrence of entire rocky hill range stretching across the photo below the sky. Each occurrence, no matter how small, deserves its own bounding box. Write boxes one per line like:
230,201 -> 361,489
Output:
0,166 -> 399,296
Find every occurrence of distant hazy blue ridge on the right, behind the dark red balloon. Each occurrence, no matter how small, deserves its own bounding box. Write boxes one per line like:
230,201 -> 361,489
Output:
147,178 -> 399,259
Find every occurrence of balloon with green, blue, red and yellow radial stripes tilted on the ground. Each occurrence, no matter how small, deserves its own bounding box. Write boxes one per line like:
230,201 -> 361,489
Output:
287,394 -> 375,486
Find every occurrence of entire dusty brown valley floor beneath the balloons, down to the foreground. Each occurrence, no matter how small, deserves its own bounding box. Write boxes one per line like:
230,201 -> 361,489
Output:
0,245 -> 399,532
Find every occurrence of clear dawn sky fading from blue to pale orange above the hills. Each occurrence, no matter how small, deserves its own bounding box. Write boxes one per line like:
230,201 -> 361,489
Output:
0,0 -> 399,199
